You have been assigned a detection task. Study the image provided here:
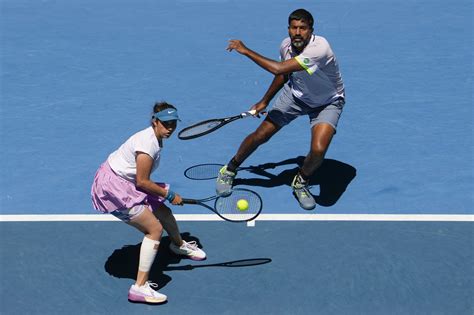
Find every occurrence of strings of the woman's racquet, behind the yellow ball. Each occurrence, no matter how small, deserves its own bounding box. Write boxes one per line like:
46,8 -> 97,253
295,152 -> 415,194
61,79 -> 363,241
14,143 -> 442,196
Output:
215,190 -> 262,221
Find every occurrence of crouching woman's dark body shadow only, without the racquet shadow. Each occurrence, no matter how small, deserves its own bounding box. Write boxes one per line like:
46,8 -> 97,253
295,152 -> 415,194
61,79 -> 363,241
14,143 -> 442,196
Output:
104,232 -> 202,289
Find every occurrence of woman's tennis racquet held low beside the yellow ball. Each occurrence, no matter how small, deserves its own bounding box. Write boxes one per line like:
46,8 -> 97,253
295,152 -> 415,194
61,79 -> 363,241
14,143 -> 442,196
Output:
183,188 -> 263,222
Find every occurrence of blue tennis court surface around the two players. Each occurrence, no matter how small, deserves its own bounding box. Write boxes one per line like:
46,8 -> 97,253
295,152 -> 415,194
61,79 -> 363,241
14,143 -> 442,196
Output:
0,0 -> 474,314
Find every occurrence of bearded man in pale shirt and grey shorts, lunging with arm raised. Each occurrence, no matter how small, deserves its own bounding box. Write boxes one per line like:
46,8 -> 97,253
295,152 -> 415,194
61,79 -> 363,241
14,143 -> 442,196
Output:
216,9 -> 345,210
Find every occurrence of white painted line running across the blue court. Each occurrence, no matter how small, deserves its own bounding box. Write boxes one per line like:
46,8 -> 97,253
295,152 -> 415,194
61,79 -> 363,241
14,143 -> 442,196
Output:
0,213 -> 474,226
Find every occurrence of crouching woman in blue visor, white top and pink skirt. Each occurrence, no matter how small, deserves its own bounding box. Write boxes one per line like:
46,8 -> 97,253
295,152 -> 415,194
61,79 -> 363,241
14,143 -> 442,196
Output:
91,102 -> 206,303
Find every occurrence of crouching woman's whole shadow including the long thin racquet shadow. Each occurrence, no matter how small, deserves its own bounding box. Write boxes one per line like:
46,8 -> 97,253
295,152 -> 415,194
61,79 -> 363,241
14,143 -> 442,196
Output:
104,232 -> 272,289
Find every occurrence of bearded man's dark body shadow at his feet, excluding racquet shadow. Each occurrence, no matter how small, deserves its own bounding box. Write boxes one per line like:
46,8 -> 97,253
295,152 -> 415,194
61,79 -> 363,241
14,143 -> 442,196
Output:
234,156 -> 357,207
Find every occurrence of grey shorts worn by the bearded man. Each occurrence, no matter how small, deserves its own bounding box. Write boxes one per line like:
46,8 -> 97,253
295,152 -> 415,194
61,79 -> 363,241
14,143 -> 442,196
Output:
267,86 -> 345,131
